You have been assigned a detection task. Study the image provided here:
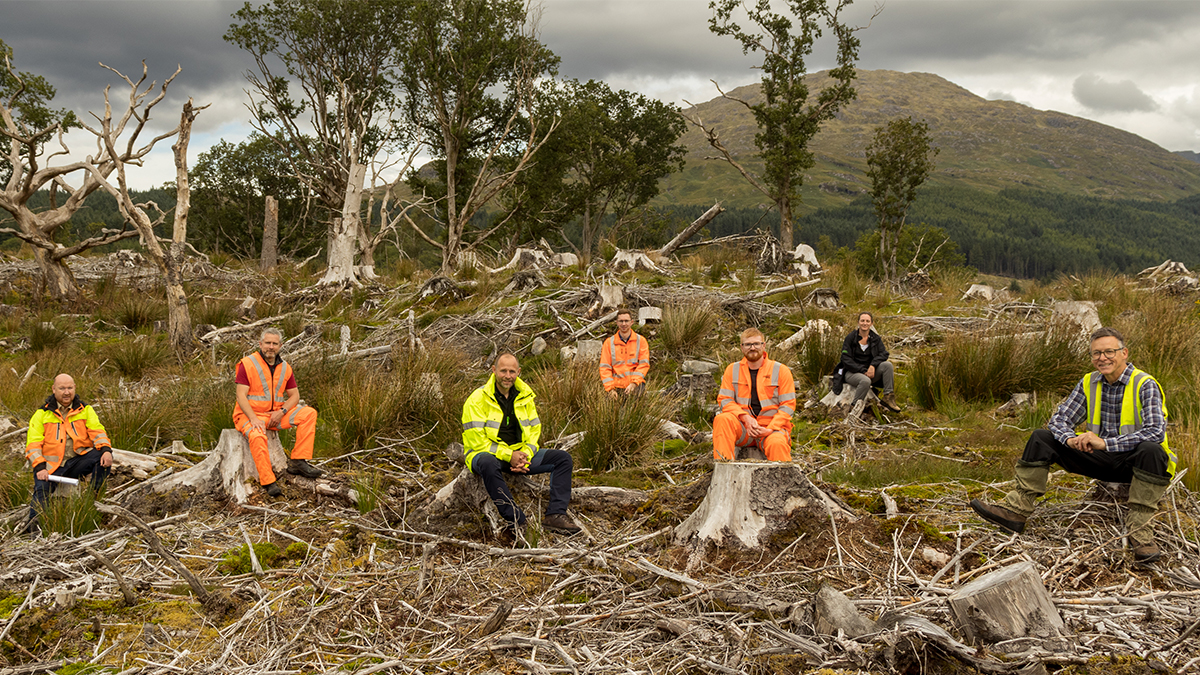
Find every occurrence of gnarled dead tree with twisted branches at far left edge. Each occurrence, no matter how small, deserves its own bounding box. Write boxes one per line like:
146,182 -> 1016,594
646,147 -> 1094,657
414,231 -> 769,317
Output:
0,48 -> 145,300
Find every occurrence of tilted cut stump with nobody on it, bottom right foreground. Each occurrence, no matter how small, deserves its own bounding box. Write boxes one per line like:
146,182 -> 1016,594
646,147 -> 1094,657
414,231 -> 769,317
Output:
947,562 -> 1067,645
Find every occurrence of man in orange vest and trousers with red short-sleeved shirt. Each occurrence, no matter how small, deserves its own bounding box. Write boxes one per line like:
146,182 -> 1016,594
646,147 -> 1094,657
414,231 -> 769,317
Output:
233,328 -> 324,497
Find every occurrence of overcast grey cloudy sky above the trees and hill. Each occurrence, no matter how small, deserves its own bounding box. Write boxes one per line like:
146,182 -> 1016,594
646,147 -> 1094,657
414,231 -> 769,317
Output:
0,0 -> 1200,187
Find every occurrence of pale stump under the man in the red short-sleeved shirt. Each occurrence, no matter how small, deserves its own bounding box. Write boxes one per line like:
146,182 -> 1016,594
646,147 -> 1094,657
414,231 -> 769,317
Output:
154,429 -> 288,504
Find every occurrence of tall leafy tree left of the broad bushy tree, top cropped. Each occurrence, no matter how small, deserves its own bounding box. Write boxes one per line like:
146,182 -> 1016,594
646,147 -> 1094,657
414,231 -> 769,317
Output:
403,0 -> 558,271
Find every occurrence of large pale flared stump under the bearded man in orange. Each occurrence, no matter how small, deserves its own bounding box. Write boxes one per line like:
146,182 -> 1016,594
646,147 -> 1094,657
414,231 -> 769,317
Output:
674,461 -> 857,568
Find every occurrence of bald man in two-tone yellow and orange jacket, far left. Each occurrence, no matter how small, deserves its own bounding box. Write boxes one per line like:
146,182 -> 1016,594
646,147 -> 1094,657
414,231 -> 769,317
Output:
25,374 -> 113,533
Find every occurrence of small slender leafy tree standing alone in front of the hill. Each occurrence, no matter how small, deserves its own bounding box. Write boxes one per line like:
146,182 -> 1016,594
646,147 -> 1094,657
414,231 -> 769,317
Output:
866,117 -> 940,281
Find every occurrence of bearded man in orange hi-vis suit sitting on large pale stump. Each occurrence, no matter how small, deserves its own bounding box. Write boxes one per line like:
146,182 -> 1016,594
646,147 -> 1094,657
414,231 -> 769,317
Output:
713,328 -> 796,461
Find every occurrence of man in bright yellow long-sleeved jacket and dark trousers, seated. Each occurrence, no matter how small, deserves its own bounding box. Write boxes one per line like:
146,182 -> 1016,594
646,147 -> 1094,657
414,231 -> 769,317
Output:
462,353 -> 580,542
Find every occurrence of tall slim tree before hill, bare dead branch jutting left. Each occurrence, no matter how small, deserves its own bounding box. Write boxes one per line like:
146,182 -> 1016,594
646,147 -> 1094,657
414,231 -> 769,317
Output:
688,0 -> 859,249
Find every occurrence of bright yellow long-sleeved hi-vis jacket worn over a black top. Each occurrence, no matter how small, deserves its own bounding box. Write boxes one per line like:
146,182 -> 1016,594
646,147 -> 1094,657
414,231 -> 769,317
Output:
462,374 -> 541,468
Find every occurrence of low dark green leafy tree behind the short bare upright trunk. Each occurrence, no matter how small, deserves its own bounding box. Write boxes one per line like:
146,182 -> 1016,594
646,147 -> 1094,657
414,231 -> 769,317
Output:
191,133 -> 325,258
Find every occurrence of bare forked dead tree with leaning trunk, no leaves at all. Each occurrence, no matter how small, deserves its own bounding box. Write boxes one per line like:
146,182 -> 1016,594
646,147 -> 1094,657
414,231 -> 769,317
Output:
83,61 -> 206,359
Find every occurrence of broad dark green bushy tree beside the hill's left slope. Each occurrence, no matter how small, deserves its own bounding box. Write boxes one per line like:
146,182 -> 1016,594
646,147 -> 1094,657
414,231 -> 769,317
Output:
511,79 -> 686,259
